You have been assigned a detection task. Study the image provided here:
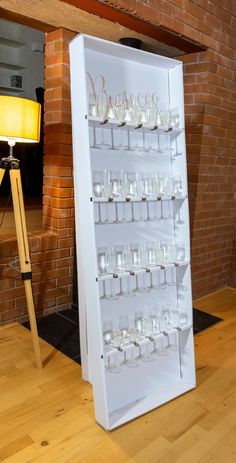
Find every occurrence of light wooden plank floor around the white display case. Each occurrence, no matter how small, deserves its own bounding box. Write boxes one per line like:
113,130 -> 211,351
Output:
0,289 -> 236,463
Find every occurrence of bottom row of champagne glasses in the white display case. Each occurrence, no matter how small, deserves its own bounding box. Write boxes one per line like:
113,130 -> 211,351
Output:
103,305 -> 188,373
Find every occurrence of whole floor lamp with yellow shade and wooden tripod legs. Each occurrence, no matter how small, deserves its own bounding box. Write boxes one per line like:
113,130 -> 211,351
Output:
0,96 -> 42,368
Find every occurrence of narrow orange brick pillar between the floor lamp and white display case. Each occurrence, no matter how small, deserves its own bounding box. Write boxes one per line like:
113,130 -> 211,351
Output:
43,29 -> 74,306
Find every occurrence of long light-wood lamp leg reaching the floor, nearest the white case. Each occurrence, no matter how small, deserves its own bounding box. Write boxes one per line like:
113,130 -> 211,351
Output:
8,163 -> 42,368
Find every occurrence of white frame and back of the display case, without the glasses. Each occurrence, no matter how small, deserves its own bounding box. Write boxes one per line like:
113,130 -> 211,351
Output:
70,35 -> 195,429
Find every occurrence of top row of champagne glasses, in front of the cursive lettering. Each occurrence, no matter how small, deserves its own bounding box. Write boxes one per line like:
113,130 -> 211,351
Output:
89,91 -> 179,153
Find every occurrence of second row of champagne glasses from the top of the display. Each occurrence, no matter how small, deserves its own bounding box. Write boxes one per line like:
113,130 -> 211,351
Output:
93,170 -> 183,223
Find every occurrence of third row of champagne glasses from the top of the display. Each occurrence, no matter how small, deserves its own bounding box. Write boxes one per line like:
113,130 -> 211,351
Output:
97,240 -> 186,299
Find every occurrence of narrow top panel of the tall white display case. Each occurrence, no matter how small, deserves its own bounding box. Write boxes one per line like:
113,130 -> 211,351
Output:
70,34 -> 182,70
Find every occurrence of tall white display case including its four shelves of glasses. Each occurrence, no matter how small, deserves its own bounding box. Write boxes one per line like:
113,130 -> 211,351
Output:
70,35 -> 195,429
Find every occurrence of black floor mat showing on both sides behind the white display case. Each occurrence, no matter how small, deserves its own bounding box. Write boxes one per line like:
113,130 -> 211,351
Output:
23,309 -> 222,364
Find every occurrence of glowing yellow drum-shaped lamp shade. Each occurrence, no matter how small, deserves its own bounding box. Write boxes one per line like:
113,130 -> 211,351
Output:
0,96 -> 41,143
